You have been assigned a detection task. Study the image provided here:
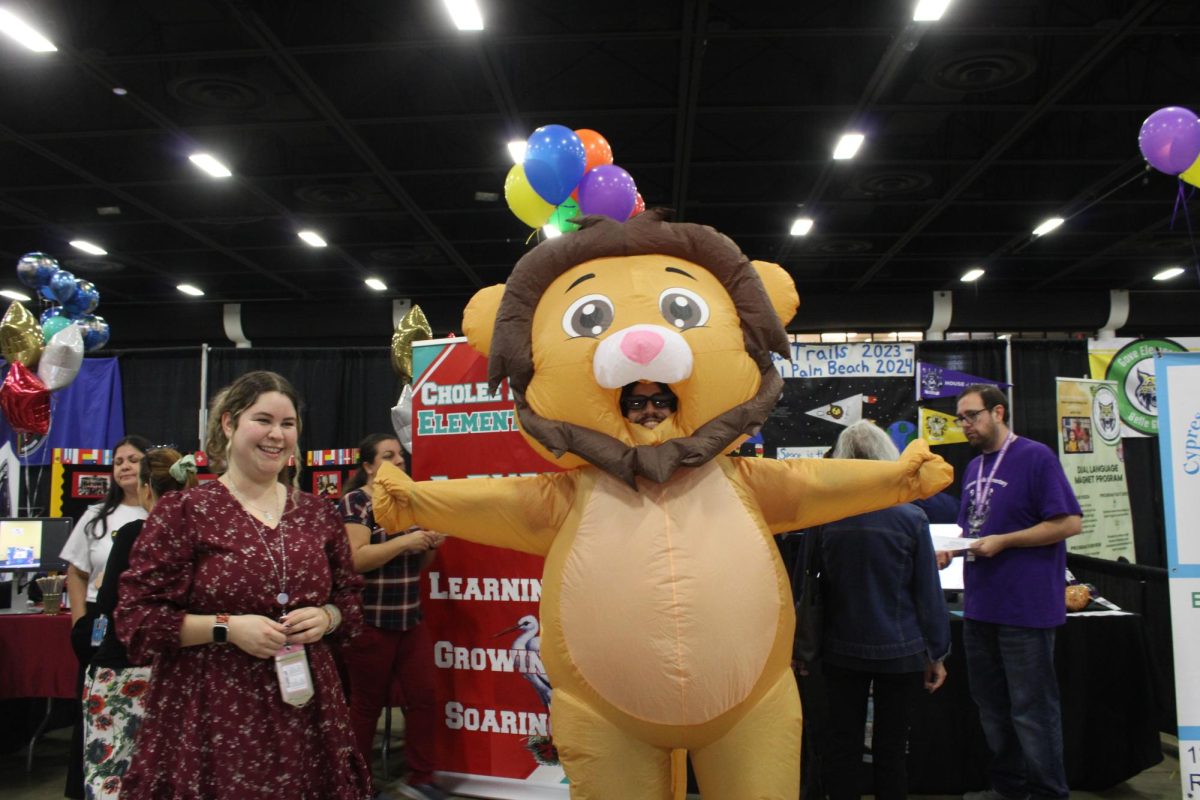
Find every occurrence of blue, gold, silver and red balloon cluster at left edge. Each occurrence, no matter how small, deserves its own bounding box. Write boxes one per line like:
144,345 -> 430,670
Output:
0,253 -> 109,441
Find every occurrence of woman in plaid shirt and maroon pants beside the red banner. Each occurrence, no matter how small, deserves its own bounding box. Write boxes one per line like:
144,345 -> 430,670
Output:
342,433 -> 446,800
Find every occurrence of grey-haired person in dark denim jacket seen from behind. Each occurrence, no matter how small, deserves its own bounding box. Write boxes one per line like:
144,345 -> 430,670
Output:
810,420 -> 950,800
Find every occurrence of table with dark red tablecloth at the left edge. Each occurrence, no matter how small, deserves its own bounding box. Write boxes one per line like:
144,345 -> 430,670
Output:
0,612 -> 79,769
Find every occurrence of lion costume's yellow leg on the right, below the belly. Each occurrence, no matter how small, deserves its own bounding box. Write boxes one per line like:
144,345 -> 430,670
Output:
691,672 -> 803,800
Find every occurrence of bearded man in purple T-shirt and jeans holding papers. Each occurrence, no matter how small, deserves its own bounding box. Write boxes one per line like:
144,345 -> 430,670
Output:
940,384 -> 1082,800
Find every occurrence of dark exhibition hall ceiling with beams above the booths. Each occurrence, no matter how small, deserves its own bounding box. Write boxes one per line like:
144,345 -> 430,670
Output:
0,0 -> 1200,313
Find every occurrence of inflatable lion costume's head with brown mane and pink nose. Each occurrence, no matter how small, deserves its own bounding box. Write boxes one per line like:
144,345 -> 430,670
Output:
463,210 -> 799,486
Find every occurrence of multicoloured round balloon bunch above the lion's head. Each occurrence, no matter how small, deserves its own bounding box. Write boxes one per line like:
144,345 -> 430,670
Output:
504,125 -> 646,233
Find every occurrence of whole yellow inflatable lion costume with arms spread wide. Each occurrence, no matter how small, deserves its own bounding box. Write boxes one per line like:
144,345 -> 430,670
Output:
374,211 -> 950,800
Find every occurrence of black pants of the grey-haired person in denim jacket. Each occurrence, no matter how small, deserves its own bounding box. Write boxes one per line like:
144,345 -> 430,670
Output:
821,664 -> 924,800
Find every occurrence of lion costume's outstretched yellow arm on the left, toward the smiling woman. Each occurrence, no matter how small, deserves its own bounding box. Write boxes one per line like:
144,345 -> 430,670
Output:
372,463 -> 575,555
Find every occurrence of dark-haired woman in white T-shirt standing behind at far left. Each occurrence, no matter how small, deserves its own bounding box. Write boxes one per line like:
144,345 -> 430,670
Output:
59,434 -> 150,799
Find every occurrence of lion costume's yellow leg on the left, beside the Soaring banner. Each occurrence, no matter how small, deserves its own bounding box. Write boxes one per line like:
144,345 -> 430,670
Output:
550,688 -> 671,800
